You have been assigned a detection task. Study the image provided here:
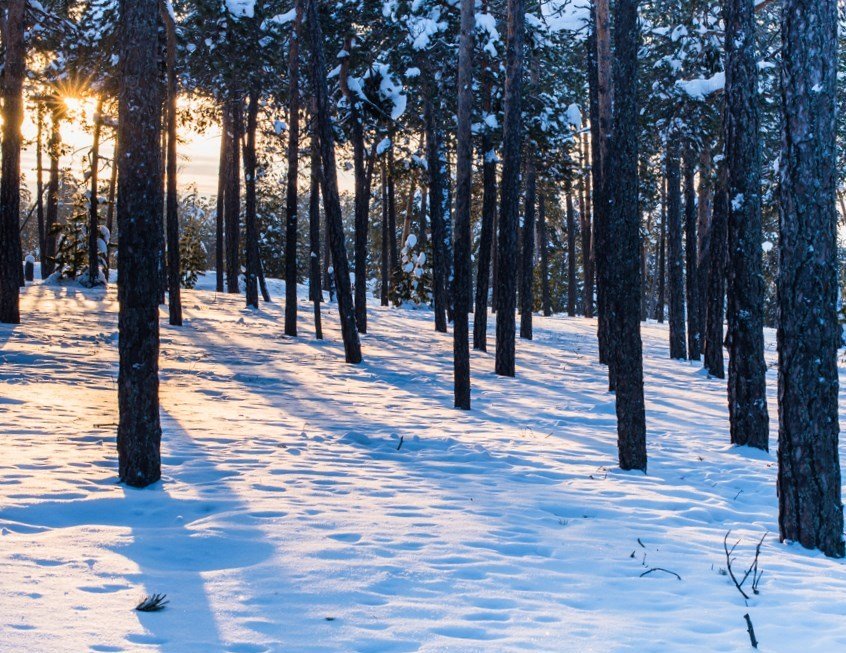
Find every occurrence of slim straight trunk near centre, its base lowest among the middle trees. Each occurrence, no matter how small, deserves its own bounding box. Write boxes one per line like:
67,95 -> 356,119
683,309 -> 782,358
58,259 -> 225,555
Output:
452,0 -> 475,410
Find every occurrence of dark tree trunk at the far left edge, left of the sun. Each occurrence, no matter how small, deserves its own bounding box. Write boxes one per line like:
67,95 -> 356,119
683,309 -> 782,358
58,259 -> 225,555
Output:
0,0 -> 26,324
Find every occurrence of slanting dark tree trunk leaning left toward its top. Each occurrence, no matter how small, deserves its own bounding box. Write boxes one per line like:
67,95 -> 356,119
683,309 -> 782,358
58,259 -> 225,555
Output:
306,0 -> 361,364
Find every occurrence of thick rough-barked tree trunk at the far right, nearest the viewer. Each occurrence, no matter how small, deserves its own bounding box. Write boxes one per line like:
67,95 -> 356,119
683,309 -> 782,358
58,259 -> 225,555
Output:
778,0 -> 844,558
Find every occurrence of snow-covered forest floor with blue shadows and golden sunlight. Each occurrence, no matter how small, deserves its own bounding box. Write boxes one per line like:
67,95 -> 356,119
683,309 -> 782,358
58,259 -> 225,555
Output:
0,278 -> 846,653
